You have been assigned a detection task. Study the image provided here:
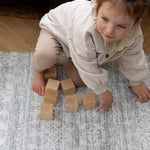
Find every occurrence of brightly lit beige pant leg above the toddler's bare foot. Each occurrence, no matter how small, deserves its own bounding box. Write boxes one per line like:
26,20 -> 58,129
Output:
32,29 -> 62,72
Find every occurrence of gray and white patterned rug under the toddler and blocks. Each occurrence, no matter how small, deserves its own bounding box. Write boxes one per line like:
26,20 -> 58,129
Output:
0,52 -> 150,150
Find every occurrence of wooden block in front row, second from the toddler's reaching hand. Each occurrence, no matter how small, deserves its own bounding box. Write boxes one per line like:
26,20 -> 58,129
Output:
66,95 -> 79,112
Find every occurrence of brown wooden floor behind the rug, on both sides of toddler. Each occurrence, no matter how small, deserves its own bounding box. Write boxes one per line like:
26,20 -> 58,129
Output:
0,16 -> 150,53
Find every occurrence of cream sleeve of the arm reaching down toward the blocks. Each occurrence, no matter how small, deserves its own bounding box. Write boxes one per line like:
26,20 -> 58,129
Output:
69,33 -> 108,94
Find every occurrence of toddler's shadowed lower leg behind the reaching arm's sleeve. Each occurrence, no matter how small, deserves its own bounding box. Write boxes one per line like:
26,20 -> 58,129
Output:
66,58 -> 85,87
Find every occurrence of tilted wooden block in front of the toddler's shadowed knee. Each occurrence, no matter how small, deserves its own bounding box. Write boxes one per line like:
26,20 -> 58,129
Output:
61,79 -> 75,96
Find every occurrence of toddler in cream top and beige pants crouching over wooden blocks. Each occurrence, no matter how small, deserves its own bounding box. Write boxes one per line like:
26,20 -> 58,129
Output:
32,0 -> 150,111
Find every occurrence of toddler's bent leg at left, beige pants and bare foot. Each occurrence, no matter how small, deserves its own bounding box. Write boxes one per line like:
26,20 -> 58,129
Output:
32,29 -> 62,95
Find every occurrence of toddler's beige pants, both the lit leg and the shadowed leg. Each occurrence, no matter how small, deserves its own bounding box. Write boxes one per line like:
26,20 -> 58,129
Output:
32,29 -> 85,86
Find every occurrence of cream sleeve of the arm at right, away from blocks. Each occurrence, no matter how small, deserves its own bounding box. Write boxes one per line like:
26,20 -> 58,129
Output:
119,36 -> 148,86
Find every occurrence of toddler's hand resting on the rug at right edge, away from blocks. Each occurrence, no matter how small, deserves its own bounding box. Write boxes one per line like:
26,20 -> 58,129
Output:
131,82 -> 150,103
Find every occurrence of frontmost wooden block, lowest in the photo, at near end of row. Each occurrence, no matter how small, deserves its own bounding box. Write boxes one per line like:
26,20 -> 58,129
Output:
40,103 -> 53,120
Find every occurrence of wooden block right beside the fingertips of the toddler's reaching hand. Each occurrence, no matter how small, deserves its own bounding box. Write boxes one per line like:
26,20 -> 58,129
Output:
81,93 -> 96,110
